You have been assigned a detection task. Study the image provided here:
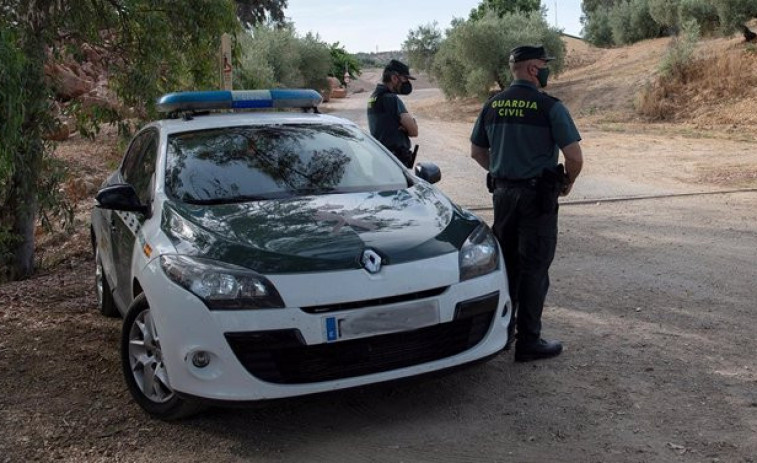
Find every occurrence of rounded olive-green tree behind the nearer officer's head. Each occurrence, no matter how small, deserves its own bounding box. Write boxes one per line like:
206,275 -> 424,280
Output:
432,12 -> 565,98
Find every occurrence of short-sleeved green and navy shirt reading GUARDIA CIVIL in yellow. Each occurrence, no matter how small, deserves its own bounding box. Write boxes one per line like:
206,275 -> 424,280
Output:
470,80 -> 581,180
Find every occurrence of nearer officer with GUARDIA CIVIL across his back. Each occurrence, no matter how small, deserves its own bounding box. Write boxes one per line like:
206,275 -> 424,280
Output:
471,46 -> 583,362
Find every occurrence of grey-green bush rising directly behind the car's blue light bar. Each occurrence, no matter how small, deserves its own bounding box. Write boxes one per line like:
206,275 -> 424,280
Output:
234,25 -> 332,90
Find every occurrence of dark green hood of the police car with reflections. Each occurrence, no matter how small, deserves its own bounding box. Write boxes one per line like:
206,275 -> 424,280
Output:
162,184 -> 480,273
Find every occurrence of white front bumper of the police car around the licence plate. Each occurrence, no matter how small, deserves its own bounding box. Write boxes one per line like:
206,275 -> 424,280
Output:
141,254 -> 510,402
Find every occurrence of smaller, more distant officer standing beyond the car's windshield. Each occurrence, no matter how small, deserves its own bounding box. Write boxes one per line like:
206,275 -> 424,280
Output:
368,60 -> 418,169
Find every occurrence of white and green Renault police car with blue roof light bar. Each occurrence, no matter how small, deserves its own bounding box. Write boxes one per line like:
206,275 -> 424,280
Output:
92,90 -> 510,419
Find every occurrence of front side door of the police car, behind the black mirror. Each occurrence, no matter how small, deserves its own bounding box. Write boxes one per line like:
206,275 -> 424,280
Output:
111,129 -> 158,307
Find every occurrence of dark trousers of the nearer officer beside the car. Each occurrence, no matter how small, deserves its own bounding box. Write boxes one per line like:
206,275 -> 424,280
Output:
493,185 -> 557,343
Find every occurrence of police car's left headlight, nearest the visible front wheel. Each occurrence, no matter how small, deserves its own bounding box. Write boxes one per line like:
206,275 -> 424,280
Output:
160,254 -> 284,310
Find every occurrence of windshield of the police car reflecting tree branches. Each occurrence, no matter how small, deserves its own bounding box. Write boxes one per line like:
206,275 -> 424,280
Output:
166,124 -> 408,204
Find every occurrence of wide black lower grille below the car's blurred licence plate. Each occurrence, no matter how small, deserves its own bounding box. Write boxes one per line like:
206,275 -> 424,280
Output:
225,292 -> 499,384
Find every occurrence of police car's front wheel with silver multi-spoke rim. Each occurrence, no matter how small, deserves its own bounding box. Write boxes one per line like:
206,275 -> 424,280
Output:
121,293 -> 202,420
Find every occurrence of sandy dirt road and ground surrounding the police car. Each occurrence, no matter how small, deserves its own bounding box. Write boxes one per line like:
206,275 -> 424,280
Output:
0,85 -> 757,463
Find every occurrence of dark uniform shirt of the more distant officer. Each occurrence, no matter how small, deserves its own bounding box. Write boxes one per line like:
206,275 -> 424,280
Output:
368,84 -> 410,153
